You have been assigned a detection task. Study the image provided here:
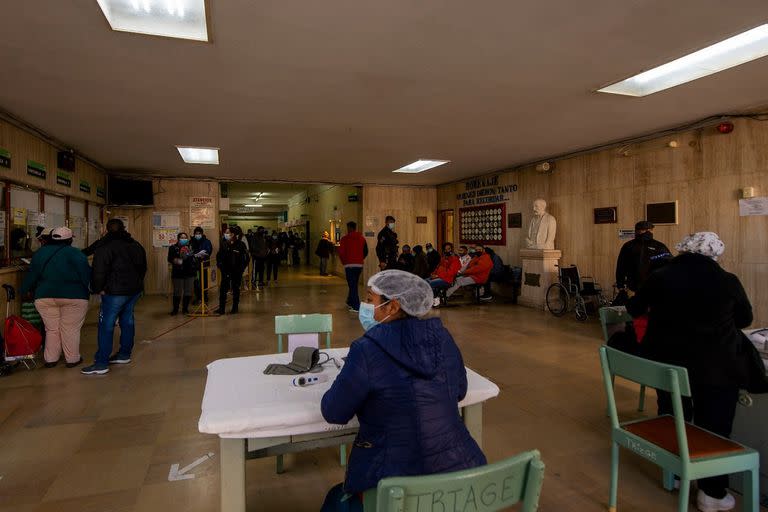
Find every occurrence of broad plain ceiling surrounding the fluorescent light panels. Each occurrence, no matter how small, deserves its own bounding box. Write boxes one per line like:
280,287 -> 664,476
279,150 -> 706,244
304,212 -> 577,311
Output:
0,0 -> 768,184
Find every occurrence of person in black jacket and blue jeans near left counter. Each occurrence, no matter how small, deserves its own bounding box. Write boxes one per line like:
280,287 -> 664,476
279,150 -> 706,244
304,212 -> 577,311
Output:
80,219 -> 147,375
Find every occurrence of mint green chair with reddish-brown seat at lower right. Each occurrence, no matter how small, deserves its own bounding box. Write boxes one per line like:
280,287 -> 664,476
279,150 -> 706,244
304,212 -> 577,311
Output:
600,346 -> 760,512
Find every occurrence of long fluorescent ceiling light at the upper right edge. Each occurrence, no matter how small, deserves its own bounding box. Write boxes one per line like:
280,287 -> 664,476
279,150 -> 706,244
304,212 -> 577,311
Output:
598,24 -> 768,96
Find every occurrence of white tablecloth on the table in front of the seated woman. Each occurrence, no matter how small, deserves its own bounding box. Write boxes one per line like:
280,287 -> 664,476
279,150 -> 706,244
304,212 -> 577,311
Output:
198,348 -> 499,438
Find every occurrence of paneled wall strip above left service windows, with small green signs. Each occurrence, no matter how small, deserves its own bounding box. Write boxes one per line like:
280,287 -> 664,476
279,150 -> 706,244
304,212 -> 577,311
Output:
0,119 -> 106,204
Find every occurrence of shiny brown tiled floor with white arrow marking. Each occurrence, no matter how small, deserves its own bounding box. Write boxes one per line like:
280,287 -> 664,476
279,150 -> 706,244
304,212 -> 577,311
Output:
0,270 -> 760,512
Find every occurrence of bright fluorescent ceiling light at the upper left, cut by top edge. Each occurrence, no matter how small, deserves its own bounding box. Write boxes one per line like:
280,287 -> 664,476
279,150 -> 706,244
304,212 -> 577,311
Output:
97,0 -> 208,41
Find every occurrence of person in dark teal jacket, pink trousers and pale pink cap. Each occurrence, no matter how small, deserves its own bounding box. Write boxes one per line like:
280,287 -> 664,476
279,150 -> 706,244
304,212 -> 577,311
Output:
21,227 -> 91,368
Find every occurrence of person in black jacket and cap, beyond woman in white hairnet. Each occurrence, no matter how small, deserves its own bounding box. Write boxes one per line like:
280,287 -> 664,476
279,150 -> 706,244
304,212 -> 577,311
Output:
616,220 -> 672,292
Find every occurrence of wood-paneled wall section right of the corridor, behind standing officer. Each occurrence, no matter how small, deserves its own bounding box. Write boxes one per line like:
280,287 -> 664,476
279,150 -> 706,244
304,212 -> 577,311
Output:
360,185 -> 437,279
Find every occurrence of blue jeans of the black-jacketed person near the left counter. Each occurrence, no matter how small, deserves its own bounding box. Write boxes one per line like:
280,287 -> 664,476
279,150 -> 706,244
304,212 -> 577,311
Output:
94,293 -> 141,367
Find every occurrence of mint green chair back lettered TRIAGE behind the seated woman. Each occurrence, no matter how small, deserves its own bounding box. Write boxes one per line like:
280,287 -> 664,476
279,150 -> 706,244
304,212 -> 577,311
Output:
363,450 -> 544,512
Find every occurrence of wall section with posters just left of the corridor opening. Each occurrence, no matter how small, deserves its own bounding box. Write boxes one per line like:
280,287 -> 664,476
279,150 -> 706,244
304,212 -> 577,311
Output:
108,179 -> 219,294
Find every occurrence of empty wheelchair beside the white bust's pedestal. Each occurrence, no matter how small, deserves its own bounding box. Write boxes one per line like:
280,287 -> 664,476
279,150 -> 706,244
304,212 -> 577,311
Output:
546,265 -> 609,322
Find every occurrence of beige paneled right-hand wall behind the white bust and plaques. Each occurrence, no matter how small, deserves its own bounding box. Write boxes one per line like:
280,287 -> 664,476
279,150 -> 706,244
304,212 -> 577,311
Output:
438,119 -> 768,325
